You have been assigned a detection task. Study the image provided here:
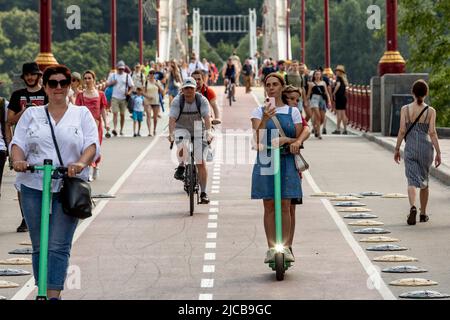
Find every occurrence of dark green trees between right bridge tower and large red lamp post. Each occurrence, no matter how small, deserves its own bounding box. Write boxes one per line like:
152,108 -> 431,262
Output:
291,0 -> 385,84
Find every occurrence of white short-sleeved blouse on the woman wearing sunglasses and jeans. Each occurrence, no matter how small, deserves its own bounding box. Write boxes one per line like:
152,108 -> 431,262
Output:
9,104 -> 100,192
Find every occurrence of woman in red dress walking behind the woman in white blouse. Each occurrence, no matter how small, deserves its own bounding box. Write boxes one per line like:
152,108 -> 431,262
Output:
75,70 -> 111,181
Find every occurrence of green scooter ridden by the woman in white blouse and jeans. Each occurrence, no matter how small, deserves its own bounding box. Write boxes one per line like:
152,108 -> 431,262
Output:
27,160 -> 67,300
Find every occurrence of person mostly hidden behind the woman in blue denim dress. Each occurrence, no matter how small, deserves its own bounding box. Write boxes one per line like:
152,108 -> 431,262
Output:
281,85 -> 310,252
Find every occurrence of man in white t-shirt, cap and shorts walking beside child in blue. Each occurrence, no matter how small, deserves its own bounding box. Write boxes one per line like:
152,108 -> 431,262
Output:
106,61 -> 134,136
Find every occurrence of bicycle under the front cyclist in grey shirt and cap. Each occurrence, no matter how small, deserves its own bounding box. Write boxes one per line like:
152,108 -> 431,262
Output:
170,138 -> 200,216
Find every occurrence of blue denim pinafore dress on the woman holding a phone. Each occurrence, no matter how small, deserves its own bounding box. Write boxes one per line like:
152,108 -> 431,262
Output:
251,108 -> 302,200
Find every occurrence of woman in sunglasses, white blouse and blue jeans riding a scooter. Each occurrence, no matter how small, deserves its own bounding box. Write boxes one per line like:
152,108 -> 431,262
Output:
10,65 -> 100,300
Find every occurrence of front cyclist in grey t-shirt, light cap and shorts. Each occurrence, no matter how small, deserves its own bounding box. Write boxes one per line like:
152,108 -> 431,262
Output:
168,78 -> 213,204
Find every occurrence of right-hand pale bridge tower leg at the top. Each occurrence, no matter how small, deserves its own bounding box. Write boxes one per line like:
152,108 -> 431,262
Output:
263,0 -> 291,60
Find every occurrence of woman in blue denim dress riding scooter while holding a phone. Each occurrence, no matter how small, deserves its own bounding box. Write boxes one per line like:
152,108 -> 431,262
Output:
251,73 -> 302,263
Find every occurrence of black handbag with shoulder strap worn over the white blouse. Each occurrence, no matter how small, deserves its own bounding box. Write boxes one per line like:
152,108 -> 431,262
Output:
45,108 -> 92,220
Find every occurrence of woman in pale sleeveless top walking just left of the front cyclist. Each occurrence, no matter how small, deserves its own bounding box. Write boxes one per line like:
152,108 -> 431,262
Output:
144,69 -> 163,137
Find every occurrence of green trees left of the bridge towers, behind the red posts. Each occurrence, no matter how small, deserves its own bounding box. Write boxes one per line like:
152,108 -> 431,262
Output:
0,0 -> 156,97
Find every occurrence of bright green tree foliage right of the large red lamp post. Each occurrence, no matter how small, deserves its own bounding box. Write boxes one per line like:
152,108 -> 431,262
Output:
400,0 -> 450,127
